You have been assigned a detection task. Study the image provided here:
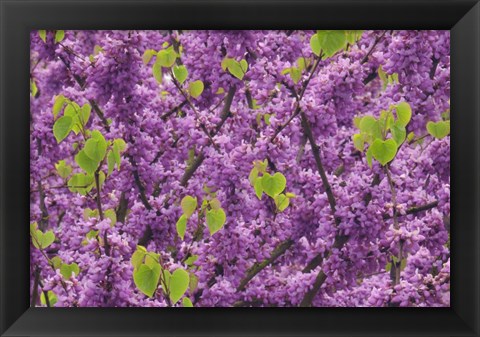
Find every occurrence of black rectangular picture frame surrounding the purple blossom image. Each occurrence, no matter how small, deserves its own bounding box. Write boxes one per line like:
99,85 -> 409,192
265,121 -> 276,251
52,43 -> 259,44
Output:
0,0 -> 480,336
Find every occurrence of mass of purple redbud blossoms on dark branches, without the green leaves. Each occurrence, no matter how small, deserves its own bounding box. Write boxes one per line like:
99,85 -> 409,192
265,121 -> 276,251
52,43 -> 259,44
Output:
30,31 -> 450,307
